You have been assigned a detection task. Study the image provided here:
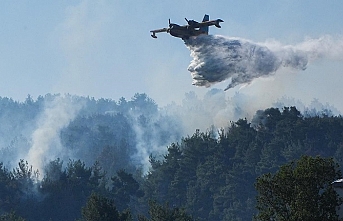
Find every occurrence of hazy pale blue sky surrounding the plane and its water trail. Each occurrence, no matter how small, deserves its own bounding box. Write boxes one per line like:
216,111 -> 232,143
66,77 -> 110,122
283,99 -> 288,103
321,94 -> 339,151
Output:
0,0 -> 343,109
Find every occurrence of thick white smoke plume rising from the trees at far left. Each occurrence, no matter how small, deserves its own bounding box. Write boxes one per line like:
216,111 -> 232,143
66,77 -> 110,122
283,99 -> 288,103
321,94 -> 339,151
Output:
24,96 -> 82,174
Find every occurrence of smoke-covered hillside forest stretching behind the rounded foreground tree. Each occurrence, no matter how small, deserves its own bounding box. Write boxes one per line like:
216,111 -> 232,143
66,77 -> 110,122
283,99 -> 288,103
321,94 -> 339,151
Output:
0,90 -> 343,221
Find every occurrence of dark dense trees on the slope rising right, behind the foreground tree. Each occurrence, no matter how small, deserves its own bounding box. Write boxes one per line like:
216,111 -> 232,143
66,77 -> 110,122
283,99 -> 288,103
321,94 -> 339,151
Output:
144,107 -> 343,220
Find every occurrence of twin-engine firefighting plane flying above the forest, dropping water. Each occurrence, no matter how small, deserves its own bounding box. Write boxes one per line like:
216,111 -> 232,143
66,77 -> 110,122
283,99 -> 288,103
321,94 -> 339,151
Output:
150,15 -> 224,40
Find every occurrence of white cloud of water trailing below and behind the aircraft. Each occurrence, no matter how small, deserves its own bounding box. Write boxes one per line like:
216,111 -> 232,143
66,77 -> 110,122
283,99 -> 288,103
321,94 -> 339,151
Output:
185,35 -> 343,90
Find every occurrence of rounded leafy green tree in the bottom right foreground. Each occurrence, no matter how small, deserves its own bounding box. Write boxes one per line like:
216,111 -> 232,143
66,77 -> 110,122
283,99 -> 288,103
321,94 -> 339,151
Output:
256,156 -> 341,221
